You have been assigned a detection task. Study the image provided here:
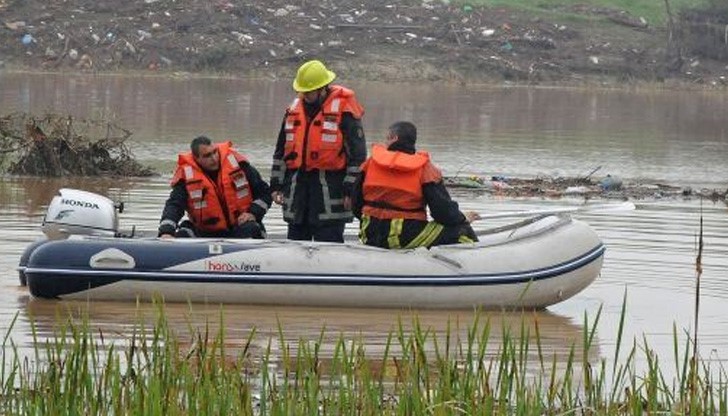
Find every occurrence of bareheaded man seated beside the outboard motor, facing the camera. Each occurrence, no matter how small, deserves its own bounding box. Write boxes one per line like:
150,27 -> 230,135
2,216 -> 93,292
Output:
159,136 -> 271,238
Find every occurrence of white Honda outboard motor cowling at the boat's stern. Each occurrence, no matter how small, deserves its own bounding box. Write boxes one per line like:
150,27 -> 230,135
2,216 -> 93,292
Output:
42,188 -> 120,240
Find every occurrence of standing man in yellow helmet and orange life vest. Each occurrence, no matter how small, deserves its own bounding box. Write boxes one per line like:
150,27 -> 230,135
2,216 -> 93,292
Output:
270,60 -> 366,242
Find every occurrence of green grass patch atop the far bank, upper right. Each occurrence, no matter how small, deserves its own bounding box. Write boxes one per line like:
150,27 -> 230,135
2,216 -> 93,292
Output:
454,0 -> 717,26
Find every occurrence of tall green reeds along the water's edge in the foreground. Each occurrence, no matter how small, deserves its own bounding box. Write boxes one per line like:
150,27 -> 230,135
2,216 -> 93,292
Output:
0,302 -> 728,415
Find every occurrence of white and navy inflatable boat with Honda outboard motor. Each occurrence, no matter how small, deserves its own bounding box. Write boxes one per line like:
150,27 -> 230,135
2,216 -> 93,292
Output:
19,189 -> 605,308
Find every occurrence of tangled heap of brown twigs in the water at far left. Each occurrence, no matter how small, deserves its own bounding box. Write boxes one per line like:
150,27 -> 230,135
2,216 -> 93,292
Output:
0,113 -> 156,177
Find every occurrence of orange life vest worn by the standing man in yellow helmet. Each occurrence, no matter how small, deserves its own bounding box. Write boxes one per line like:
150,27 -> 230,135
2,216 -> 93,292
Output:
283,85 -> 364,171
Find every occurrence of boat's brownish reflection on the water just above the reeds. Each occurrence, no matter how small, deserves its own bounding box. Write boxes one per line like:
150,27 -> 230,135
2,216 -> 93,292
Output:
18,296 -> 599,380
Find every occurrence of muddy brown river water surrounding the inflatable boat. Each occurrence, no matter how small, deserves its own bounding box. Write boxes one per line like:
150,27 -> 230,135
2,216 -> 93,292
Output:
0,74 -> 728,373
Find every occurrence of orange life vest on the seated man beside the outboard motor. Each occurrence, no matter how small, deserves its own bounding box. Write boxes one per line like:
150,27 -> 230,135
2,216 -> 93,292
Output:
172,142 -> 253,232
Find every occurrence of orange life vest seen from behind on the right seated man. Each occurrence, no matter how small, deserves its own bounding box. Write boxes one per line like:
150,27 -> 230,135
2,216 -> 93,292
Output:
362,144 -> 432,221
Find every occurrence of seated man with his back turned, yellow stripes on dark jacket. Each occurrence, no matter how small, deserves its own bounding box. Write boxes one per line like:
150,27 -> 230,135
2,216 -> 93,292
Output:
352,121 -> 479,248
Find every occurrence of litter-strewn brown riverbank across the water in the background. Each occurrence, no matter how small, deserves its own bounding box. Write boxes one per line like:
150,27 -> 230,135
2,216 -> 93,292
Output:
0,0 -> 728,88
